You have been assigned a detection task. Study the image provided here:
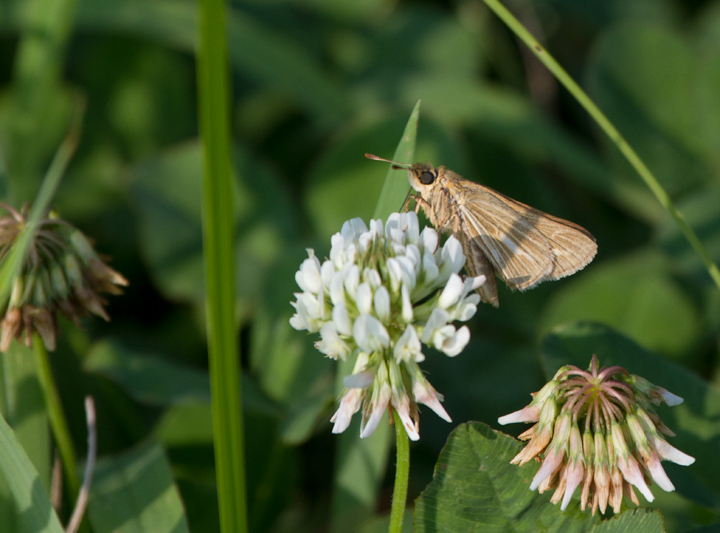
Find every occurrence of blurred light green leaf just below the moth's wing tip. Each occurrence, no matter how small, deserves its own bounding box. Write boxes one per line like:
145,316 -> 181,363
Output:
540,252 -> 701,358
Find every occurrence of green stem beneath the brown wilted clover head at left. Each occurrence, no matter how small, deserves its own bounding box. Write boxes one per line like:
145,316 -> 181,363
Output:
33,334 -> 80,501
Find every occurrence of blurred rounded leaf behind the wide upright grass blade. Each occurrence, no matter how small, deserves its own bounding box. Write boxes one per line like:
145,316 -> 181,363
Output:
132,142 -> 295,301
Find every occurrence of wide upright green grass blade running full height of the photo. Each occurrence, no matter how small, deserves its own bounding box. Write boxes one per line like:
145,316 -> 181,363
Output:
197,0 -> 247,533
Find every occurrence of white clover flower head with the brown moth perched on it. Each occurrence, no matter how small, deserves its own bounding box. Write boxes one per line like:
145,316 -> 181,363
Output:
290,212 -> 485,440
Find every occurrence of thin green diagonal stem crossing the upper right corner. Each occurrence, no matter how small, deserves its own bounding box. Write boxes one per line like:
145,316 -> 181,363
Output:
484,0 -> 720,294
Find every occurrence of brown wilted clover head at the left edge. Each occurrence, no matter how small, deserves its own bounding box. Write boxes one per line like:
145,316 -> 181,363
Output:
0,204 -> 128,352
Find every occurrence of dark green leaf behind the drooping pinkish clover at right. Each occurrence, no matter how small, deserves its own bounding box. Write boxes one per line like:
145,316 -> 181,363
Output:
542,322 -> 720,510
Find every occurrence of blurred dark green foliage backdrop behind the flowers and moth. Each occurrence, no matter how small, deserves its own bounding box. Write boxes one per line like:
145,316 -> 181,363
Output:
0,0 -> 720,532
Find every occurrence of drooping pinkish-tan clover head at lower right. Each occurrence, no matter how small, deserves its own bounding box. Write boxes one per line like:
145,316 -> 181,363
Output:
498,355 -> 695,514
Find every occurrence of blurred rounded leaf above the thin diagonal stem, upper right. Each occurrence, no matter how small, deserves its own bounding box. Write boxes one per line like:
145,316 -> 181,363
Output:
588,24 -> 712,195
